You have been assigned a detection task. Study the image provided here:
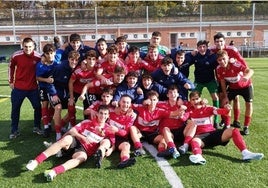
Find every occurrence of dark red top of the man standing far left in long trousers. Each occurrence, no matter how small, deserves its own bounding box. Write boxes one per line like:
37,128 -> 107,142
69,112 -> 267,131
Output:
8,50 -> 41,90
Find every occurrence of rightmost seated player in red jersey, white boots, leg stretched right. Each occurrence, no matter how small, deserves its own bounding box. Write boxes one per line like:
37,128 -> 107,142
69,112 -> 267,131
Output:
184,91 -> 264,165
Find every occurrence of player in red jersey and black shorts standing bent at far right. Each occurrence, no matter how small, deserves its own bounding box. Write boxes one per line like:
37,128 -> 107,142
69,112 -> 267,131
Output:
216,50 -> 254,135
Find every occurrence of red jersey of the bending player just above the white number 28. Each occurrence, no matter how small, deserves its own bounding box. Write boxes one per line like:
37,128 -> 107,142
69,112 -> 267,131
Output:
70,66 -> 96,93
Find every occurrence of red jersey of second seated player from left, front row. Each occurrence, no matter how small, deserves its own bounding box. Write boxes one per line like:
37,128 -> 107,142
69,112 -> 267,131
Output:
108,112 -> 135,138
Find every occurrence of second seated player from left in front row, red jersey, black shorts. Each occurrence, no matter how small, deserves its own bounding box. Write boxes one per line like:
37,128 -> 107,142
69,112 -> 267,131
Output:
108,95 -> 137,168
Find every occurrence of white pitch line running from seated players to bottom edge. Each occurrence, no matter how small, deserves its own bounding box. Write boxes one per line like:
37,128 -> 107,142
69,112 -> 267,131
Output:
143,142 -> 183,188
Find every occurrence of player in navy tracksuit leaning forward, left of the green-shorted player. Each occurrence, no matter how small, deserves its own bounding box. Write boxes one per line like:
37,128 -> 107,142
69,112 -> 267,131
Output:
152,56 -> 194,100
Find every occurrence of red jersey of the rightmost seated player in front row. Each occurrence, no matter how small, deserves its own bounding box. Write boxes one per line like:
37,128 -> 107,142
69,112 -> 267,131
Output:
189,106 -> 229,135
